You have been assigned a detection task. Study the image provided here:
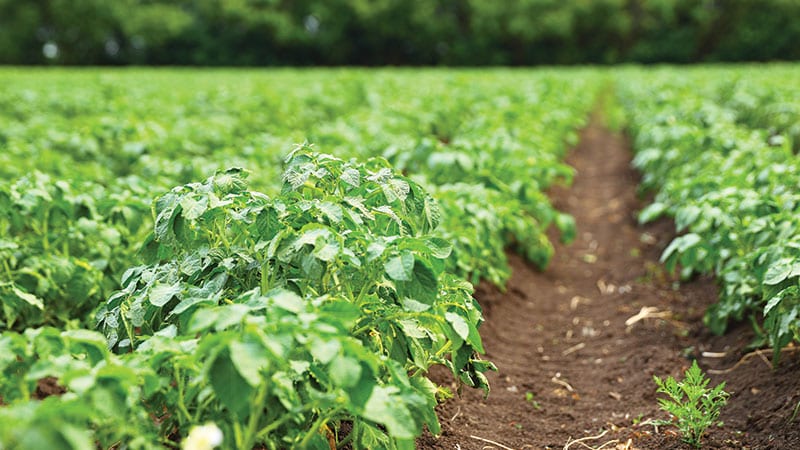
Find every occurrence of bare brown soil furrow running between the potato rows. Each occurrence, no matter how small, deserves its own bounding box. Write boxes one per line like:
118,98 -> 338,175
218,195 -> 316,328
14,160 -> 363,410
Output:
418,120 -> 800,450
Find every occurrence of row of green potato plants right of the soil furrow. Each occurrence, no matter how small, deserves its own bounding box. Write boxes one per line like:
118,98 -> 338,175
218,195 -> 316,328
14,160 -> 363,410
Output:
618,68 -> 800,361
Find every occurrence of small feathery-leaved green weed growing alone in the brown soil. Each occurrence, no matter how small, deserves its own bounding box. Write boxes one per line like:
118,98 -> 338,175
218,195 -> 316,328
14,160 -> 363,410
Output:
653,361 -> 730,448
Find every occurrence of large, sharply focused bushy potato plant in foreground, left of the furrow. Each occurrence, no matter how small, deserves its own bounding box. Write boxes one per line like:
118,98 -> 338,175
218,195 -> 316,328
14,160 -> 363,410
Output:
97,147 -> 493,449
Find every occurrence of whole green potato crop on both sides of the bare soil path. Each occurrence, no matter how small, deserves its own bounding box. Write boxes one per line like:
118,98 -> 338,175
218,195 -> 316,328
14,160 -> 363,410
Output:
0,66 -> 800,449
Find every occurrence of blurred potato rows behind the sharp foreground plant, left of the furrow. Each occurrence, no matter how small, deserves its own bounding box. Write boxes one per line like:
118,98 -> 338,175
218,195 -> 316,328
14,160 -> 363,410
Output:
0,71 -> 594,330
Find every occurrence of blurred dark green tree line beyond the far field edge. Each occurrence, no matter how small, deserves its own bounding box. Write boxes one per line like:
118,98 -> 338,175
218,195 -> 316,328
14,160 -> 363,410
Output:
0,0 -> 800,66
